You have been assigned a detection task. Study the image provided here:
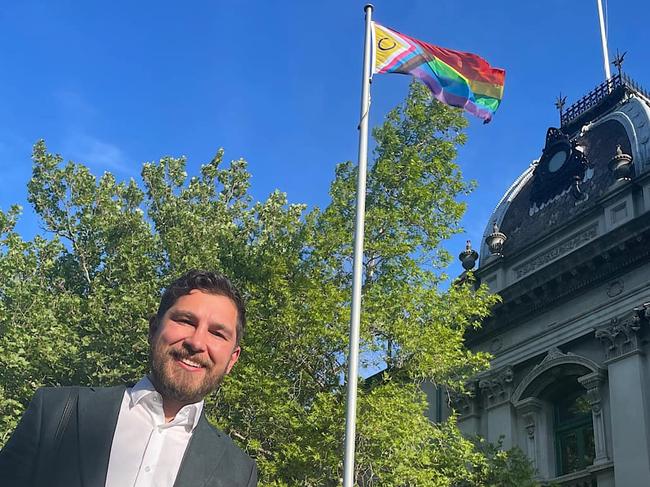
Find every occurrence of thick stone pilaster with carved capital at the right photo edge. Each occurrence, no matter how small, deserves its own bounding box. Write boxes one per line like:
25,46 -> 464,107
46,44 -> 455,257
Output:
586,305 -> 650,485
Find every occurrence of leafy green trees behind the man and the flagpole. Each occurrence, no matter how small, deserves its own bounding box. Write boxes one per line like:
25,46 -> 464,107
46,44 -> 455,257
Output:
0,85 -> 536,487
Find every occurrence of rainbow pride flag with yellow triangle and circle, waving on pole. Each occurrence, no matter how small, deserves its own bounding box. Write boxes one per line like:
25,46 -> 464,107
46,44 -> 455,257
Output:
372,22 -> 506,123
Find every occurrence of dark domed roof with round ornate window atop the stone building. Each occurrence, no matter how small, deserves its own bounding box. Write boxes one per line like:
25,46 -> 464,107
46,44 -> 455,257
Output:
480,84 -> 650,267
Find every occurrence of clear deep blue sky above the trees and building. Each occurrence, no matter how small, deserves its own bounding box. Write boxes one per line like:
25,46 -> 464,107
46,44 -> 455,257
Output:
0,0 -> 650,274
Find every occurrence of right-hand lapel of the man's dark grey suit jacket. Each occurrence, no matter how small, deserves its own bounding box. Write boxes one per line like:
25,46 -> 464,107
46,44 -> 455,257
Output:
174,414 -> 224,487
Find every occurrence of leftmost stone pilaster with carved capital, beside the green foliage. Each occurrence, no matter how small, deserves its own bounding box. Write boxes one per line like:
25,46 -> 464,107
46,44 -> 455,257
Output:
479,366 -> 517,449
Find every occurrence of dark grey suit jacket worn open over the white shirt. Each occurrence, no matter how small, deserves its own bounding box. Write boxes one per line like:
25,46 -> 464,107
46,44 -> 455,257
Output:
0,386 -> 257,487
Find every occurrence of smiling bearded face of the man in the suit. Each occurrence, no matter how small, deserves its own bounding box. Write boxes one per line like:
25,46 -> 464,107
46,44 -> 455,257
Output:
149,289 -> 241,404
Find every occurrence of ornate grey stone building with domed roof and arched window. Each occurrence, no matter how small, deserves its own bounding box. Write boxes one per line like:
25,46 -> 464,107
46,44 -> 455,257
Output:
453,70 -> 650,487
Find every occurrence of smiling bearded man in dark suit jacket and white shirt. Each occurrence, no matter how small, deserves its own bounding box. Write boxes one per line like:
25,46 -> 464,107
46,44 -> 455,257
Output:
0,271 -> 257,487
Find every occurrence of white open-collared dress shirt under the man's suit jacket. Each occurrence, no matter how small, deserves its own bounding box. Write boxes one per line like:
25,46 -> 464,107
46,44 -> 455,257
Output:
105,377 -> 203,487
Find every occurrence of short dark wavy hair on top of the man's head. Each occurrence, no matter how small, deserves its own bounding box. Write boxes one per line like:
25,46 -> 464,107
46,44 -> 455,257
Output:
155,269 -> 246,345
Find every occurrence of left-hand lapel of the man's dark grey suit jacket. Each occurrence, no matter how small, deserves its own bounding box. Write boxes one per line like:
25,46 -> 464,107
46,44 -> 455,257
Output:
77,386 -> 125,487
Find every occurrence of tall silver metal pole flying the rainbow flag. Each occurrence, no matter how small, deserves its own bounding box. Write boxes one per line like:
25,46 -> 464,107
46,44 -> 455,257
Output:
343,4 -> 373,487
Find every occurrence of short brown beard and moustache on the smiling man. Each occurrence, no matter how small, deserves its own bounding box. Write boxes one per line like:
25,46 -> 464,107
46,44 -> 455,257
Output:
149,341 -> 226,404
